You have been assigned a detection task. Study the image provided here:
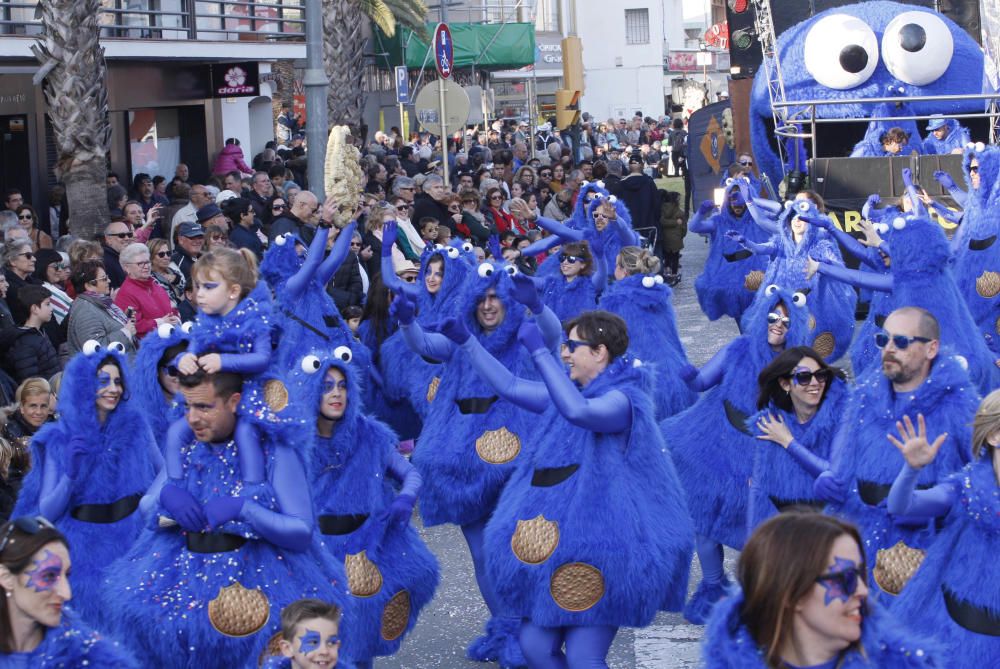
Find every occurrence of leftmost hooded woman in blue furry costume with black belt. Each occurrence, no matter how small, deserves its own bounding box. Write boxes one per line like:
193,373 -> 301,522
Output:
13,340 -> 163,623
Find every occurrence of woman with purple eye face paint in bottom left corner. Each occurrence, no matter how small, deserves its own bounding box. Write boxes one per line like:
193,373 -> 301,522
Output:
0,516 -> 140,669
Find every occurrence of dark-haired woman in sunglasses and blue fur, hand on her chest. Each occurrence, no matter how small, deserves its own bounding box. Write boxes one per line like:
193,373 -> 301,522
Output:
747,346 -> 848,532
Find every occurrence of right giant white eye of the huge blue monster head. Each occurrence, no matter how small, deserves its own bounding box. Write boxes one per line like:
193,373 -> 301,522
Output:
882,12 -> 955,86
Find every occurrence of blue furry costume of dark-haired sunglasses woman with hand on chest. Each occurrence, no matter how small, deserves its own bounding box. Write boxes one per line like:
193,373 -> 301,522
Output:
747,368 -> 849,534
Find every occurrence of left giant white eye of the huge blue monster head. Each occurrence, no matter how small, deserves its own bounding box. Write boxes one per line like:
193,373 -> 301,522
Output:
804,14 -> 879,91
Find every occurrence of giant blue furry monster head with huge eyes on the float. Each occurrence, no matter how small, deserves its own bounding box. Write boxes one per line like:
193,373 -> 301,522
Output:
750,0 -> 983,185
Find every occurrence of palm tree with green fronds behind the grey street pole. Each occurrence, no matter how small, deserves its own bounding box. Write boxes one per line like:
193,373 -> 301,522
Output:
323,0 -> 427,128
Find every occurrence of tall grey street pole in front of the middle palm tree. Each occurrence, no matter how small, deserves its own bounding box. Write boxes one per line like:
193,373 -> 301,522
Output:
302,0 -> 329,202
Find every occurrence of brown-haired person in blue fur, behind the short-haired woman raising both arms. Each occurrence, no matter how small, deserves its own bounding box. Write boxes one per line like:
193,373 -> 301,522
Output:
600,246 -> 698,421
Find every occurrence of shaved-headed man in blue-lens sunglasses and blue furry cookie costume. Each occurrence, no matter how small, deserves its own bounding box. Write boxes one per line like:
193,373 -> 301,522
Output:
815,307 -> 979,594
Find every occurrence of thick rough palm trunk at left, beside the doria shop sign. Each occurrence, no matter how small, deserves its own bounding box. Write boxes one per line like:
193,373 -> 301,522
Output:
31,0 -> 111,239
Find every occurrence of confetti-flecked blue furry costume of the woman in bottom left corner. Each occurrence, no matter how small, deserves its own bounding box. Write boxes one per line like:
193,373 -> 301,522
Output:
0,608 -> 142,669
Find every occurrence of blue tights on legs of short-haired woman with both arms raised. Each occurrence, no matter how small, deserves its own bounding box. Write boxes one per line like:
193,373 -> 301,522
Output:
521,621 -> 618,669
